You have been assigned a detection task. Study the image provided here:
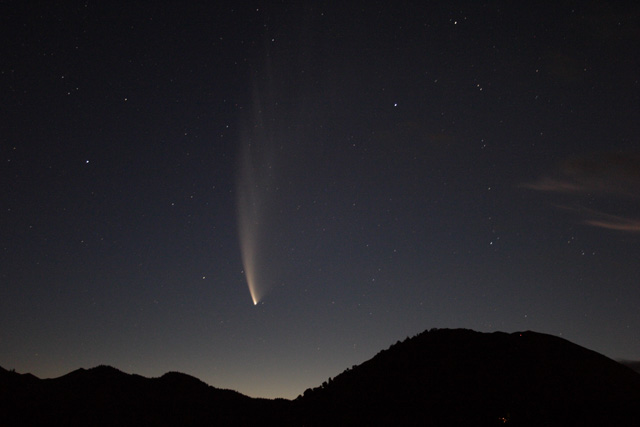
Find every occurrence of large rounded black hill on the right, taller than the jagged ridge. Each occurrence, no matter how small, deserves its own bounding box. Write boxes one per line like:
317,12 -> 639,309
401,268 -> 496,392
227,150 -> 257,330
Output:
296,330 -> 640,425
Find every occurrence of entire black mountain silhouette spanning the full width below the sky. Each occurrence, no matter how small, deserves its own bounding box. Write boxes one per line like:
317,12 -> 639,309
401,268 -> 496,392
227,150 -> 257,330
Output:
0,329 -> 640,426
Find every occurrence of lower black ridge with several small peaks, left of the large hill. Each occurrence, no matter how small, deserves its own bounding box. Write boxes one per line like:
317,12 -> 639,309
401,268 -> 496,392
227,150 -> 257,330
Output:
0,366 -> 290,426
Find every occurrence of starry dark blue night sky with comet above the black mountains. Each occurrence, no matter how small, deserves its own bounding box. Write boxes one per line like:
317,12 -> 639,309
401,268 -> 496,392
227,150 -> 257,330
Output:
0,0 -> 640,398
